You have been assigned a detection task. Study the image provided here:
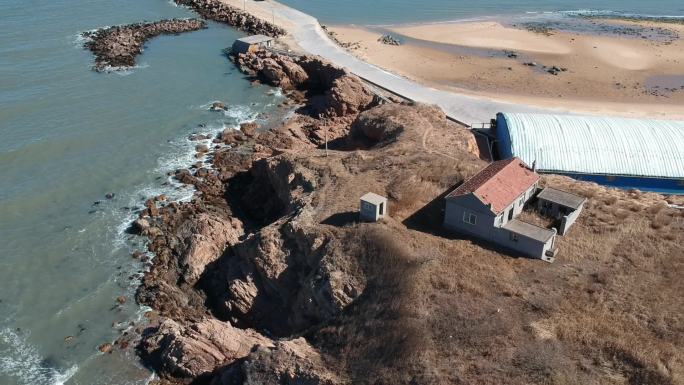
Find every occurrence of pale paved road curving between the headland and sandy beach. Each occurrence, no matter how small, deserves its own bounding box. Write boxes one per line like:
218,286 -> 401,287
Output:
264,1 -> 558,124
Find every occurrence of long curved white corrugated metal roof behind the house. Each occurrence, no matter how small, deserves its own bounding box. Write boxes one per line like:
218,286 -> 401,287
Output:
497,113 -> 684,178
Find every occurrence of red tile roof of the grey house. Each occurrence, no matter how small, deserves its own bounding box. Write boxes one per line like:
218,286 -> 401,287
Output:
446,158 -> 539,215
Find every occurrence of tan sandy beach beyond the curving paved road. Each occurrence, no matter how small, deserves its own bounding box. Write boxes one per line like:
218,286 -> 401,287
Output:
328,21 -> 684,119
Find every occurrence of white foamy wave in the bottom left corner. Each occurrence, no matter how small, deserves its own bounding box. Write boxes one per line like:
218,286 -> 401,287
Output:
0,328 -> 78,385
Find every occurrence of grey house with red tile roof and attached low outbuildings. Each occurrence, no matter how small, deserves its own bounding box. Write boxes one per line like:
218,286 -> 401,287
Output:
444,158 -> 584,262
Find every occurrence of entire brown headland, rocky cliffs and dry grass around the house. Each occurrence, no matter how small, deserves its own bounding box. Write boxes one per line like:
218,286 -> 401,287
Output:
123,47 -> 684,385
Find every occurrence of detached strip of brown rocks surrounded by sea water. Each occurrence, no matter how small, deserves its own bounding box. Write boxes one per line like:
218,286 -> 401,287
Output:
83,19 -> 206,72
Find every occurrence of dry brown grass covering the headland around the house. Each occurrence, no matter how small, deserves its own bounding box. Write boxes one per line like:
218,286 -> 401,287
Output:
278,105 -> 684,384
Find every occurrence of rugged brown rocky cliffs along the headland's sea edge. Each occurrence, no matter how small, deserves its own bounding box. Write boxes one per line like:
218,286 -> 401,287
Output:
132,52 -> 380,384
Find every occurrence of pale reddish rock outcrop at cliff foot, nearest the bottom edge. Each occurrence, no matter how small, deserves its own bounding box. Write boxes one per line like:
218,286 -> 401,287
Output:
140,319 -> 273,379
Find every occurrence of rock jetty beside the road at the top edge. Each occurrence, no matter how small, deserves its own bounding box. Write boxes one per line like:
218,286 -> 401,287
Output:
174,0 -> 287,37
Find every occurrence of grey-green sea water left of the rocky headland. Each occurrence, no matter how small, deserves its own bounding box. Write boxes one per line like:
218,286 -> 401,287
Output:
0,0 -> 279,385
